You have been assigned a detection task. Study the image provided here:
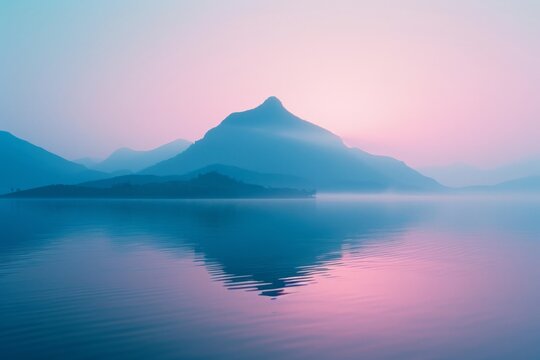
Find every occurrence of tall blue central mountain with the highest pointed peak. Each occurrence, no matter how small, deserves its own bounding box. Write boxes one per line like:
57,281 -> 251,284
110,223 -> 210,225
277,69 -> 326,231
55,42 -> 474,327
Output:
142,97 -> 443,191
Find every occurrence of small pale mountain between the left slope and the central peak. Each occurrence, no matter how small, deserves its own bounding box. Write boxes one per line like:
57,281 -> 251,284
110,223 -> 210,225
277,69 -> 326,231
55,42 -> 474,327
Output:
91,139 -> 191,172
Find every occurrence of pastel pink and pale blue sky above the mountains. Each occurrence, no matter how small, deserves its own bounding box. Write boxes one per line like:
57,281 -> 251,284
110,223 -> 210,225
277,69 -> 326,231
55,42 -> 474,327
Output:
0,0 -> 540,167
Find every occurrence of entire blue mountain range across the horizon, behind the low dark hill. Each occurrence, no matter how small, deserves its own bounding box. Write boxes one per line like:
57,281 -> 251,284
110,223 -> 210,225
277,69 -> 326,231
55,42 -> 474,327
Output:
26,97 -> 540,193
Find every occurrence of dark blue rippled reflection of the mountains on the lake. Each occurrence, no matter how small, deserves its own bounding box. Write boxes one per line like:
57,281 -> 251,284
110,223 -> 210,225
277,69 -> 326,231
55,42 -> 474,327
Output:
0,200 -> 420,296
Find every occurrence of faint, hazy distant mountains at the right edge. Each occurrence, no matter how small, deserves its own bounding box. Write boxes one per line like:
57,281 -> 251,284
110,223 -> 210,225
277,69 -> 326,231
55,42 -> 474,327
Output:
419,157 -> 540,187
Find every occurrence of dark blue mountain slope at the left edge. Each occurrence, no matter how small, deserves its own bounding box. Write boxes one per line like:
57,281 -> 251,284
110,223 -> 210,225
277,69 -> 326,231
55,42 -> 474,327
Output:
0,131 -> 105,193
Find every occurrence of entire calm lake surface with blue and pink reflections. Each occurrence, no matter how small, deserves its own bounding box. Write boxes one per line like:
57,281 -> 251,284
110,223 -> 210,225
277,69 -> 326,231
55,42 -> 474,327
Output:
0,197 -> 540,360
